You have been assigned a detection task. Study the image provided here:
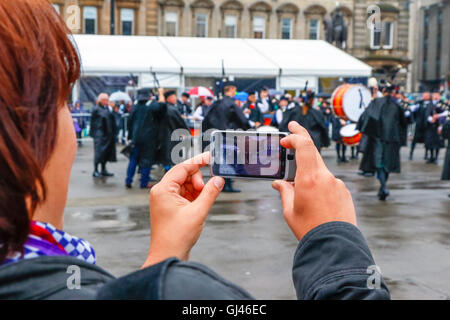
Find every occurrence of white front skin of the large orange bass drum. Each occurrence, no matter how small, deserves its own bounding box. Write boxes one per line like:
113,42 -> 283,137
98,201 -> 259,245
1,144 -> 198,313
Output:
343,85 -> 371,122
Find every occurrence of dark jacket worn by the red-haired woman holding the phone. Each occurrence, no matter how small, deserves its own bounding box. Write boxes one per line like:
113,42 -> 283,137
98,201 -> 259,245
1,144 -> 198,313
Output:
0,222 -> 390,300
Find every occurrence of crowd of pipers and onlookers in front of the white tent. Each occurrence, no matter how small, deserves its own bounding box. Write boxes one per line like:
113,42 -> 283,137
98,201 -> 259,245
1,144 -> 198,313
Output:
71,81 -> 450,200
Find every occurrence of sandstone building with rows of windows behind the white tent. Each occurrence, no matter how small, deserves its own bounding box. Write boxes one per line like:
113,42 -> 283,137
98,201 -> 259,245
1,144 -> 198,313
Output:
53,0 -> 410,87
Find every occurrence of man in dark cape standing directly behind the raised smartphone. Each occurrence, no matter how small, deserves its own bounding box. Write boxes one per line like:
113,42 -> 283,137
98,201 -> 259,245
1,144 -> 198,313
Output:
202,82 -> 251,192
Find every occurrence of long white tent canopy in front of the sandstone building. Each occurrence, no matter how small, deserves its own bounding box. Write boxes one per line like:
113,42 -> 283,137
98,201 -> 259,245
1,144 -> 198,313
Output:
74,35 -> 372,88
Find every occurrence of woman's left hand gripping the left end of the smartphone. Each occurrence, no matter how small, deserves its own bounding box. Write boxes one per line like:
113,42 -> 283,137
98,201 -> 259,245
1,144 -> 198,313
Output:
143,152 -> 225,268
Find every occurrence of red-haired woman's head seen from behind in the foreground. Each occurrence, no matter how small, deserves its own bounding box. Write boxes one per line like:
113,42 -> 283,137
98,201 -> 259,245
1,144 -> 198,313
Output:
0,0 -> 80,262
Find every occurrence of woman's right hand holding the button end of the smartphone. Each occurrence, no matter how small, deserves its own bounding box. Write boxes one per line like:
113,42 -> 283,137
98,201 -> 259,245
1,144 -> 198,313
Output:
272,121 -> 356,241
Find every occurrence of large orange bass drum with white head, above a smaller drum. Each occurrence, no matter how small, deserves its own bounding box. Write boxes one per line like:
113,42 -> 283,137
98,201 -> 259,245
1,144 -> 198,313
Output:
331,84 -> 372,122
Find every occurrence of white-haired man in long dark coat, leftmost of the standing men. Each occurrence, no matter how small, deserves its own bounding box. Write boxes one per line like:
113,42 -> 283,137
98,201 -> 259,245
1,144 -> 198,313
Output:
90,93 -> 117,178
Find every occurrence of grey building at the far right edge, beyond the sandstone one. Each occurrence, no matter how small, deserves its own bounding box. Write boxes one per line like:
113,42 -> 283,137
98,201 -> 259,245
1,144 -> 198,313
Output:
409,0 -> 450,91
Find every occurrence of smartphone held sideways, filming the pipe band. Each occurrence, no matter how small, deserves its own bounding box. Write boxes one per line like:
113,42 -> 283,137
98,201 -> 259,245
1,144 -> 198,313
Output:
210,130 -> 297,181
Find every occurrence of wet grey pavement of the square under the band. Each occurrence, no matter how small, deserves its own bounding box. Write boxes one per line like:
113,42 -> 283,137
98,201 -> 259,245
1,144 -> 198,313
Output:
65,142 -> 450,299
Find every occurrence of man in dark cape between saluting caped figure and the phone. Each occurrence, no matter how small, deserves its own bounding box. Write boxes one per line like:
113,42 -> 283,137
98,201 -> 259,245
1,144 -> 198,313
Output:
157,91 -> 189,171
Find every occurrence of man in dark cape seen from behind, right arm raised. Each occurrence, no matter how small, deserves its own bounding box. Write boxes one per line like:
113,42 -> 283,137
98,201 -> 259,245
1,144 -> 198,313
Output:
125,89 -> 166,189
